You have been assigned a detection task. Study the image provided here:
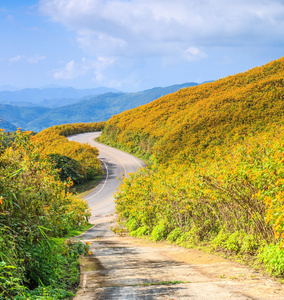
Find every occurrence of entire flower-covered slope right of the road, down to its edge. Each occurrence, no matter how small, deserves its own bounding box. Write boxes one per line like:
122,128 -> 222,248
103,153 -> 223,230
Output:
100,58 -> 284,278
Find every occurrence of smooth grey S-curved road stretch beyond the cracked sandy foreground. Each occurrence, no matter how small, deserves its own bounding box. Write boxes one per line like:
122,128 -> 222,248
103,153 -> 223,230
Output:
68,132 -> 145,222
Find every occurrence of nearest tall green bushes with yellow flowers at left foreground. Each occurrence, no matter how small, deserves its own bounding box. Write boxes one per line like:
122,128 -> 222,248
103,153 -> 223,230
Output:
0,131 -> 90,299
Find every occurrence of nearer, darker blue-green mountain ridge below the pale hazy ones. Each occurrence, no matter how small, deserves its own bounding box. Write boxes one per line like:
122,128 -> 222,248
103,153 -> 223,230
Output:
0,83 -> 197,132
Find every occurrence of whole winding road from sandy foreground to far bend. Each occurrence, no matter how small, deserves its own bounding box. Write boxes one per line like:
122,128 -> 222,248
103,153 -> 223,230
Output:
69,133 -> 284,300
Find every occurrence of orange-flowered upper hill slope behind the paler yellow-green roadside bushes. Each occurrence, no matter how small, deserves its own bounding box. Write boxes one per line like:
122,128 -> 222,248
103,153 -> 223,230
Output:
101,58 -> 284,161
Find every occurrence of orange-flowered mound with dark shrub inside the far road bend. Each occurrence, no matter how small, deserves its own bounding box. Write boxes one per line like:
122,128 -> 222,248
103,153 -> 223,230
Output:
33,122 -> 104,184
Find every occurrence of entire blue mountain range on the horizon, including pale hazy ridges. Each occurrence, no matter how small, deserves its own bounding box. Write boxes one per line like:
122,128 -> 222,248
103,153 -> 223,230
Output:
0,82 -> 198,132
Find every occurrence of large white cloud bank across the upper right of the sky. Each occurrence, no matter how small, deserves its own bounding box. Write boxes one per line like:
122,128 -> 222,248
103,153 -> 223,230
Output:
39,0 -> 284,55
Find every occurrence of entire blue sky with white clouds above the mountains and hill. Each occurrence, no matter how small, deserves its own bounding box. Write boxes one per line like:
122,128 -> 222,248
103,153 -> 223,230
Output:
0,0 -> 284,91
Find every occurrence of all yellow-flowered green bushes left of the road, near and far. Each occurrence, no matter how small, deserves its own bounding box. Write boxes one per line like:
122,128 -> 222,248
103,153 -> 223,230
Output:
0,124 -> 104,300
